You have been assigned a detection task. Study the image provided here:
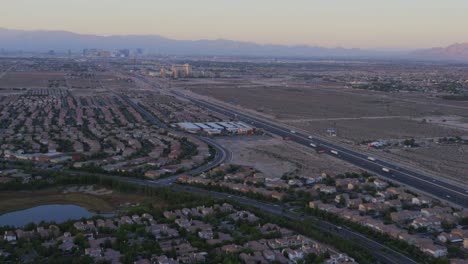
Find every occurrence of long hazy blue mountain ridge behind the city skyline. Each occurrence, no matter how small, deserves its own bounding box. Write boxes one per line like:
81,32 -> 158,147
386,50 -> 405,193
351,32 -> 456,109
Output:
0,28 -> 390,57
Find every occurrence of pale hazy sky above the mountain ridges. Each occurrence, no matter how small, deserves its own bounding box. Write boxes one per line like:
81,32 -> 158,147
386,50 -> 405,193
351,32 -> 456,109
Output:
0,0 -> 468,49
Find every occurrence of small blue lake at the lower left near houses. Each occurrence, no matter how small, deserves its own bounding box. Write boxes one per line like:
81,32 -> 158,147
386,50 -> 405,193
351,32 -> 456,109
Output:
0,204 -> 113,227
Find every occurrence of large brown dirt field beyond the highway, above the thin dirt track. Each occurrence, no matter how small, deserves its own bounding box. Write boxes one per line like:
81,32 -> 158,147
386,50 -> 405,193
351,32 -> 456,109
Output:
190,84 -> 468,120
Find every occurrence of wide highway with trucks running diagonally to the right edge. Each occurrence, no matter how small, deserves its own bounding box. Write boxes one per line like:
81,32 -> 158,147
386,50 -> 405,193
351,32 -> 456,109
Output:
172,91 -> 468,208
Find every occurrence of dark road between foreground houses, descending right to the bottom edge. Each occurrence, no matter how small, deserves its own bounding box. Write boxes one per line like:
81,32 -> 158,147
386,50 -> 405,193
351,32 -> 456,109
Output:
171,185 -> 417,264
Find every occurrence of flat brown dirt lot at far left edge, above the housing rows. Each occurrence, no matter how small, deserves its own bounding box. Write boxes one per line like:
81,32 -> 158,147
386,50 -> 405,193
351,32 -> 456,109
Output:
0,72 -> 65,88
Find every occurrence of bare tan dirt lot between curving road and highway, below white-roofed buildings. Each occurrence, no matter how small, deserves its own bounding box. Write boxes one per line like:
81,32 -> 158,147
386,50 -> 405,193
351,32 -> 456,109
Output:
216,136 -> 358,178
